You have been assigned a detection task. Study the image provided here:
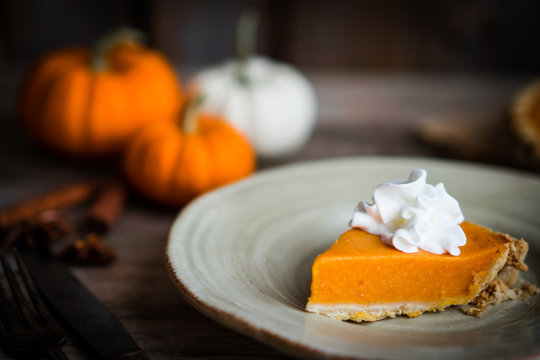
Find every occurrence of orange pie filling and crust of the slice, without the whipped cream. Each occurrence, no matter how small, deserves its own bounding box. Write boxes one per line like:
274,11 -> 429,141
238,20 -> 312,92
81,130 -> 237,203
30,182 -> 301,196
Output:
306,222 -> 535,322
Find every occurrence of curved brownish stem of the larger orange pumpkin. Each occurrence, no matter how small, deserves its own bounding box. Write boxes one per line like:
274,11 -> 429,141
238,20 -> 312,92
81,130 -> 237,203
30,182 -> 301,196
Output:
90,28 -> 146,71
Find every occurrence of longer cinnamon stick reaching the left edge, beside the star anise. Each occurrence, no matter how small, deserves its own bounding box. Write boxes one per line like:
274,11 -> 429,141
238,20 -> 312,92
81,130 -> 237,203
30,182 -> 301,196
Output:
0,181 -> 98,229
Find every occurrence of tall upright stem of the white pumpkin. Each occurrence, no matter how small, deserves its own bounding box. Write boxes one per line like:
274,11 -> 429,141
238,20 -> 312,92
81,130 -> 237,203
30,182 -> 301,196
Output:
236,9 -> 259,85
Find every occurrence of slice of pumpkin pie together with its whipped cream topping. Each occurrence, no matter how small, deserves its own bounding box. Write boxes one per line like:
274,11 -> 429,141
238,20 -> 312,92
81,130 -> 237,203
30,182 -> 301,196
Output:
306,169 -> 536,321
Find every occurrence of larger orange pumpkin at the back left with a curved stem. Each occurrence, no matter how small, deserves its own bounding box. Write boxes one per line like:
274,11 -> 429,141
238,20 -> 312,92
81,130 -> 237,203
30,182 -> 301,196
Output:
19,31 -> 183,156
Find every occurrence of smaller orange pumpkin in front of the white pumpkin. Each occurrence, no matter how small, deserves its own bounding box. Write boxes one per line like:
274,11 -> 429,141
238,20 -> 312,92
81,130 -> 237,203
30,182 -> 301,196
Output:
124,98 -> 256,206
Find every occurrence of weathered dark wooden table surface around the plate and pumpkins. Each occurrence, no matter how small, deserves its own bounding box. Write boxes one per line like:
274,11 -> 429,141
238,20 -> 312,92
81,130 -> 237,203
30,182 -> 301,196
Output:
0,69 -> 527,359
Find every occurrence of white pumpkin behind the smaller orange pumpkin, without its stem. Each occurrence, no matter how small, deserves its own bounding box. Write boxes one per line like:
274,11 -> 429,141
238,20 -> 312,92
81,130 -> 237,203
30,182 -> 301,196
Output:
189,56 -> 317,158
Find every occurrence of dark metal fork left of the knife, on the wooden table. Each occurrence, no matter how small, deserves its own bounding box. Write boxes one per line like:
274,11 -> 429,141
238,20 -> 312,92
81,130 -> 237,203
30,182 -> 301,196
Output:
0,250 -> 67,359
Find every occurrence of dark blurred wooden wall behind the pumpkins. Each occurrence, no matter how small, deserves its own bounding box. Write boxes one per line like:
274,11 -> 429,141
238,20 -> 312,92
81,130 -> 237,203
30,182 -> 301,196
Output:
0,0 -> 540,74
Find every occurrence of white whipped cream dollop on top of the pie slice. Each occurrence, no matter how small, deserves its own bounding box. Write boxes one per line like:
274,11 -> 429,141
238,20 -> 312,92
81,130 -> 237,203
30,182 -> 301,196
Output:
350,169 -> 467,256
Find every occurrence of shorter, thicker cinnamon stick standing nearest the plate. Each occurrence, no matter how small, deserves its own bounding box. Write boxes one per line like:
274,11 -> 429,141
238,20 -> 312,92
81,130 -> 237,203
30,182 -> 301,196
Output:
81,180 -> 127,234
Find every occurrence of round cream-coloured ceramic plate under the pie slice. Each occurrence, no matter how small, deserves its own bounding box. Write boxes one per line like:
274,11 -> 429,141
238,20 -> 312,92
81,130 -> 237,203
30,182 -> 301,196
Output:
166,157 -> 540,359
